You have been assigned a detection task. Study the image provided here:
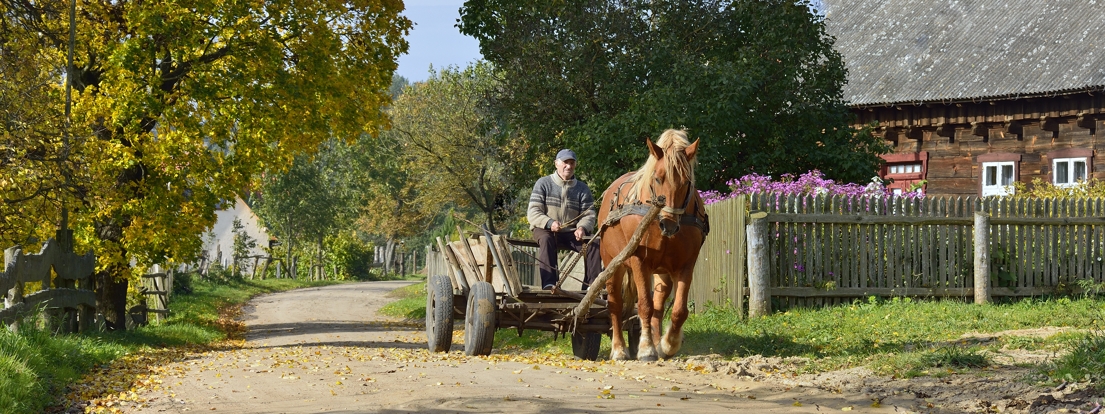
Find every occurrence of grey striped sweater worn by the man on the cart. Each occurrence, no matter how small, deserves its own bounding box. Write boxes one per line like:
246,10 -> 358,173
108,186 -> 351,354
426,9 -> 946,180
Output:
526,172 -> 596,234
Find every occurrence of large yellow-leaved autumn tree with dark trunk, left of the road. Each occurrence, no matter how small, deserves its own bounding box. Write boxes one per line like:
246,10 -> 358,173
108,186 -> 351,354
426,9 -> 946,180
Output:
0,0 -> 410,329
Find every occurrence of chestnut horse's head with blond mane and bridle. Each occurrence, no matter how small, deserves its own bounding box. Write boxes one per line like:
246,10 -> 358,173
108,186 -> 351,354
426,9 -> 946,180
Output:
639,129 -> 698,237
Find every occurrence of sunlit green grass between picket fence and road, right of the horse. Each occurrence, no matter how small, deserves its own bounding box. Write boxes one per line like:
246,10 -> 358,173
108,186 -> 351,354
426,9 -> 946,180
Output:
684,298 -> 1105,379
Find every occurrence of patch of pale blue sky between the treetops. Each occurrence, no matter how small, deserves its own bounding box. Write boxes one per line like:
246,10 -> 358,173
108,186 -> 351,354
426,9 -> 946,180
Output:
396,0 -> 482,82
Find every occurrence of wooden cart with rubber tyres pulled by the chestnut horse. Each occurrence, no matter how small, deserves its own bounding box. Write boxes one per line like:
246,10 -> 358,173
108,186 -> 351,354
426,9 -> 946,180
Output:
425,229 -> 640,360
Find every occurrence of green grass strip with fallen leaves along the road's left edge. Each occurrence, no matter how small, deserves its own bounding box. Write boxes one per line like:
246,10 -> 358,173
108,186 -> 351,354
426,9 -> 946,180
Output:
0,273 -> 334,413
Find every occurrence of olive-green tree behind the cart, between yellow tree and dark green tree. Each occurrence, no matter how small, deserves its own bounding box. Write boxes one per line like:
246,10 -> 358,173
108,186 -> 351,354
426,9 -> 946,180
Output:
390,63 -> 534,232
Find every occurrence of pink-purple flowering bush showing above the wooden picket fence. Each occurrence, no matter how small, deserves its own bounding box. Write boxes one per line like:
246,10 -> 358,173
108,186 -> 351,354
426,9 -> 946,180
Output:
698,170 -> 923,204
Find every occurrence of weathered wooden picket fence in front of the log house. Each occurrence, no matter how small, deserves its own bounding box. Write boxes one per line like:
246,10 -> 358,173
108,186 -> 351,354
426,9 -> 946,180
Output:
750,194 -> 1105,308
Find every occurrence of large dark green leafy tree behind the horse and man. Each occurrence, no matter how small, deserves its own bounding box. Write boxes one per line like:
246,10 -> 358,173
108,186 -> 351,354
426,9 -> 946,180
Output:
460,0 -> 887,190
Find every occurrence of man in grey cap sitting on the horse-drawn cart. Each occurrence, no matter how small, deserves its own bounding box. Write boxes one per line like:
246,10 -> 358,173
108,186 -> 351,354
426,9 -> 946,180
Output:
526,149 -> 602,290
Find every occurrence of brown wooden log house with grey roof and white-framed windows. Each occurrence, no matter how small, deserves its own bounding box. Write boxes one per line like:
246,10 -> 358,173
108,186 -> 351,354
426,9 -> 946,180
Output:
823,0 -> 1105,195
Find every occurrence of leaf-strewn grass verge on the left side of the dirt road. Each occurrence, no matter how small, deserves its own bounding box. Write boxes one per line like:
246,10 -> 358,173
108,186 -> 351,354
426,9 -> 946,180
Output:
0,279 -> 335,413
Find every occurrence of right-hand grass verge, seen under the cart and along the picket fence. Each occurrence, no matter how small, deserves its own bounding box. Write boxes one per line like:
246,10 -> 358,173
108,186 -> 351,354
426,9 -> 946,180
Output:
392,285 -> 1105,383
